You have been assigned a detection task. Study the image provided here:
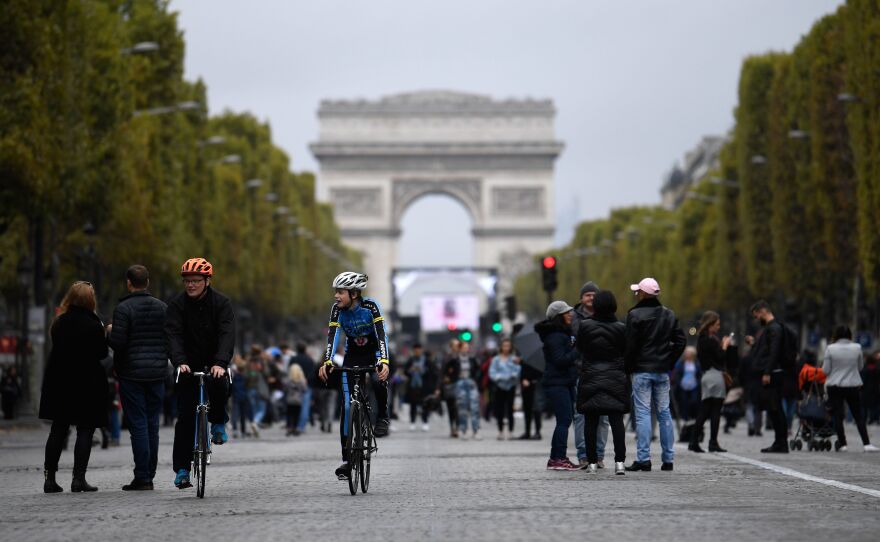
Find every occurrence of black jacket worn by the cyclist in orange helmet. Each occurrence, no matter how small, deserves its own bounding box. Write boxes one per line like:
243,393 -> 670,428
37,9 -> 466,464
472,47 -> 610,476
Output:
165,286 -> 235,371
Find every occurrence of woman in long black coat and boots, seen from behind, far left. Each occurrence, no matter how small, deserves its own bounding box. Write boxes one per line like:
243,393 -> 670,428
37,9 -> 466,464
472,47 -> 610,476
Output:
40,281 -> 107,493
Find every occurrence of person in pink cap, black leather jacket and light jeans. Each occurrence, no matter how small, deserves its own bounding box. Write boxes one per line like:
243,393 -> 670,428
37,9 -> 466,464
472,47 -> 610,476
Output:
625,278 -> 687,471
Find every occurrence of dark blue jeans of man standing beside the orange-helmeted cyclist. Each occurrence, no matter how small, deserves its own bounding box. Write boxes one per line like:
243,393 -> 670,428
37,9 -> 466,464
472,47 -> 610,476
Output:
119,379 -> 165,482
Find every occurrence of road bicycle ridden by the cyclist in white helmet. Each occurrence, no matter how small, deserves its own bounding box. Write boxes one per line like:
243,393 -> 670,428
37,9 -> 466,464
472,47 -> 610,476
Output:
334,367 -> 379,495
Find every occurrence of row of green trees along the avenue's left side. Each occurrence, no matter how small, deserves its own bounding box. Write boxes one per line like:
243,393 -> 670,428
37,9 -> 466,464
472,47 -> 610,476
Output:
0,0 -> 360,336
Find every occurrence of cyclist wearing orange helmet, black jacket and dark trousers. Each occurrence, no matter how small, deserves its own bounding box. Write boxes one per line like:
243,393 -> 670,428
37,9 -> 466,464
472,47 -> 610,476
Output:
165,258 -> 235,489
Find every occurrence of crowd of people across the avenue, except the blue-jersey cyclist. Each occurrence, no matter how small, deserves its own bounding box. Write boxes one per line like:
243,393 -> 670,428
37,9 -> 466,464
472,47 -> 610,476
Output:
8,260 -> 880,493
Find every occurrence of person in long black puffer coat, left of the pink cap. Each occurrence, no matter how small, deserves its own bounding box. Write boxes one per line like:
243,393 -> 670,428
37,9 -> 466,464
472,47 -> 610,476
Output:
575,290 -> 631,475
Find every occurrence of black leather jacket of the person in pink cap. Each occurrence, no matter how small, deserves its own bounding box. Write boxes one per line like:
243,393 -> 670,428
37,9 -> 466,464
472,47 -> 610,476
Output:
625,298 -> 687,373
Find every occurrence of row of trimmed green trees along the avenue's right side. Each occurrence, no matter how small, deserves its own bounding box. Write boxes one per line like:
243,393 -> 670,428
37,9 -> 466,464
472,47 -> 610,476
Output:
516,0 -> 880,331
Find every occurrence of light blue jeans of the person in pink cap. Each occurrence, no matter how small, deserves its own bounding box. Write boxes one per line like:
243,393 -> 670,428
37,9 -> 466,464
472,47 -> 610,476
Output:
633,373 -> 675,463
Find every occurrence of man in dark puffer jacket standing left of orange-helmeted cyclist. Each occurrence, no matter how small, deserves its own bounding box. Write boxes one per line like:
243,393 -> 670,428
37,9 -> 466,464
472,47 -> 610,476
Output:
108,265 -> 168,491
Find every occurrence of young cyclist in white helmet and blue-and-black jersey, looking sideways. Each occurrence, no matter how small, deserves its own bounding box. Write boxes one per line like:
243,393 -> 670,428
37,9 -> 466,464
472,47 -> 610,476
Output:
318,271 -> 389,480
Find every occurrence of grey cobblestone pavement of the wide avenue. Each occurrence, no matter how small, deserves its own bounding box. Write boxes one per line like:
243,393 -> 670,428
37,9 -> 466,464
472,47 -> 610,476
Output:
0,412 -> 880,541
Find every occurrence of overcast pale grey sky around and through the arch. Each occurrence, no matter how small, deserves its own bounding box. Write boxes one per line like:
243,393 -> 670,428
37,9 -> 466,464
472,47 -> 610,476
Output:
172,0 -> 842,265
